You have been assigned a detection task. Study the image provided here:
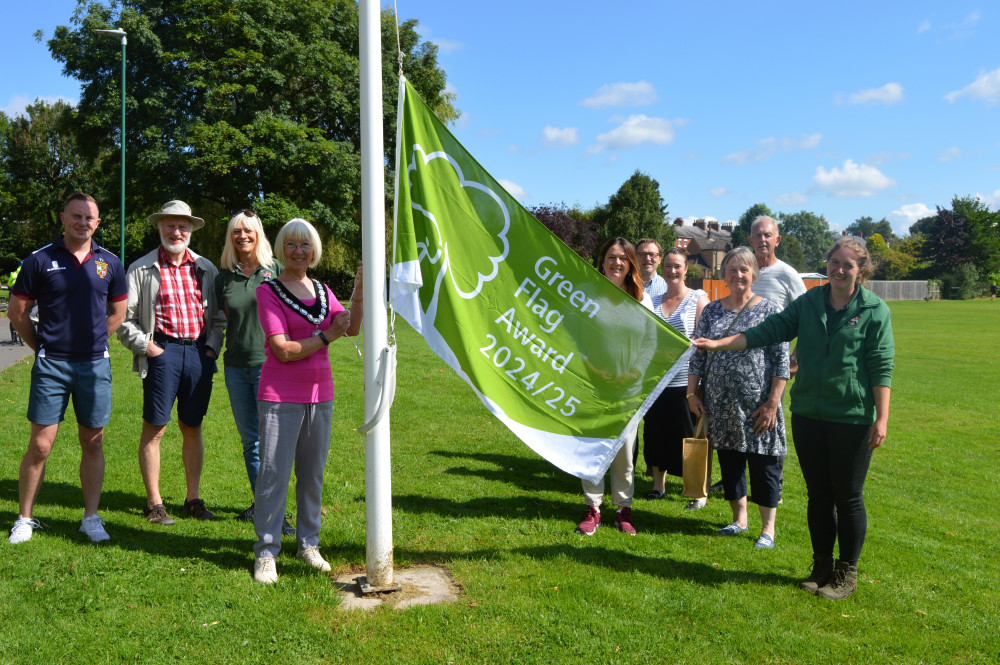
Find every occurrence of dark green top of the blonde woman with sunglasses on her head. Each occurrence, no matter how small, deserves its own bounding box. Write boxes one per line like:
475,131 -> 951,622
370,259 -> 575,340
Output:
215,266 -> 278,367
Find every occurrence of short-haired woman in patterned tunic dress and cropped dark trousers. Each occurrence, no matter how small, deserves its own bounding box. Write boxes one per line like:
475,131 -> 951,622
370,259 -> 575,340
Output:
688,247 -> 788,549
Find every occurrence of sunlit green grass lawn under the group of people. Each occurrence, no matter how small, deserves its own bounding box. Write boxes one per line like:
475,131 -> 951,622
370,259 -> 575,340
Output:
0,299 -> 1000,665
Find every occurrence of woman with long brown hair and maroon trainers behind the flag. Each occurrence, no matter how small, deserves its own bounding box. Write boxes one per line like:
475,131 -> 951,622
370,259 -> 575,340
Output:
576,238 -> 653,536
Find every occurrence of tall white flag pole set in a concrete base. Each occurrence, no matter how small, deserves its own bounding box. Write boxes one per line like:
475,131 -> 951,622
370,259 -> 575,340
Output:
358,0 -> 393,588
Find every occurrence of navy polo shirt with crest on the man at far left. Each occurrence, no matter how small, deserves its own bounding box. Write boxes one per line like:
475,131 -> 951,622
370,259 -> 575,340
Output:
11,236 -> 128,360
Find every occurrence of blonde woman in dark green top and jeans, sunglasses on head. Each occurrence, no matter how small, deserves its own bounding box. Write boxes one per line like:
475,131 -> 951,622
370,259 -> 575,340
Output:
215,210 -> 295,535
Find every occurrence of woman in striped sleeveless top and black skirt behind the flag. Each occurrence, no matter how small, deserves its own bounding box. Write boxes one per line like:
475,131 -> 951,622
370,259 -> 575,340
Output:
642,247 -> 708,509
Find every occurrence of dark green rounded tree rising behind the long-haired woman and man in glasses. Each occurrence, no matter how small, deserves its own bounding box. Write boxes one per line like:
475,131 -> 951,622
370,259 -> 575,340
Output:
594,169 -> 667,254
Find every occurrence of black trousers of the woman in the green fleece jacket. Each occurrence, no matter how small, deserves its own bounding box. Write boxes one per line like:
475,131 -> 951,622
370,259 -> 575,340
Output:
792,413 -> 872,565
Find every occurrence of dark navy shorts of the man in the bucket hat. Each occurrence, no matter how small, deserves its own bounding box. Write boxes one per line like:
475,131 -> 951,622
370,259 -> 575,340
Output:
142,341 -> 216,427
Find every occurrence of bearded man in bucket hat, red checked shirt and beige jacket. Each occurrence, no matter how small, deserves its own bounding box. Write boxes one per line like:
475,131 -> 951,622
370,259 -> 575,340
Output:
118,201 -> 225,525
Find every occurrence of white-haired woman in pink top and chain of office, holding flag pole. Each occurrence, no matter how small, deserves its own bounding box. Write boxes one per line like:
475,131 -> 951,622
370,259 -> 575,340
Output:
253,219 -> 362,584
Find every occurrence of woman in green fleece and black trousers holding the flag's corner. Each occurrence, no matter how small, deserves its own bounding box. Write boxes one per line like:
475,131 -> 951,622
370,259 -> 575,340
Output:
694,237 -> 895,599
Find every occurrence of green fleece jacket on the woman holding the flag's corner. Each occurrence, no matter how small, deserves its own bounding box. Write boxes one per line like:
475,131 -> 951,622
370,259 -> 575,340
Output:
745,284 -> 896,425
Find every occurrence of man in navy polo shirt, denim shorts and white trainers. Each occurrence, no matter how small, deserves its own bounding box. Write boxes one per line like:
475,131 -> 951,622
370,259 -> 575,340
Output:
7,193 -> 128,545
